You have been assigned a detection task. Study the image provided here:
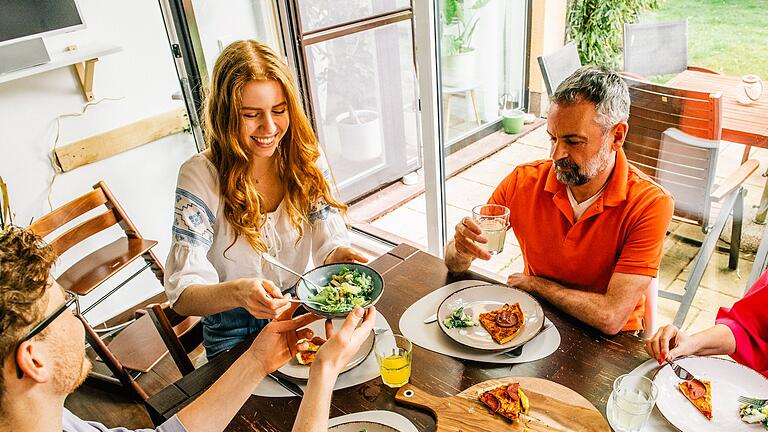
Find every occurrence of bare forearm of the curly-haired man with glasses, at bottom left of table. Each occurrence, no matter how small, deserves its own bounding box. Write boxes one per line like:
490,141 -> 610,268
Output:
179,351 -> 267,432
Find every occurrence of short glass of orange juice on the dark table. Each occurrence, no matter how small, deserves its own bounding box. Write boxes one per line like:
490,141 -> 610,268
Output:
374,334 -> 413,387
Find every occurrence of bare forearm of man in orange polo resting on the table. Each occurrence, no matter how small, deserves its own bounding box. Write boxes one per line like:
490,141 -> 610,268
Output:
526,276 -> 634,334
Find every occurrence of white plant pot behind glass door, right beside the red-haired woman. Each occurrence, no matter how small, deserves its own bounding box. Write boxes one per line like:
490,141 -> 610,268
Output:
336,110 -> 382,161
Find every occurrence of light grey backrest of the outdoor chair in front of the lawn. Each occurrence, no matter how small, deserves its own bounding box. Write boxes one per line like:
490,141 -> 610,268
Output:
624,20 -> 688,76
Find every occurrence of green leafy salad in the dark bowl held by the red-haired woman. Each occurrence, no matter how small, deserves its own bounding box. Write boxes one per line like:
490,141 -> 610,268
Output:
309,267 -> 373,313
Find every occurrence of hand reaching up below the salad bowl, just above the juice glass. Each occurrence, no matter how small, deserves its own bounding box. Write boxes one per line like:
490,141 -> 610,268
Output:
315,306 -> 376,374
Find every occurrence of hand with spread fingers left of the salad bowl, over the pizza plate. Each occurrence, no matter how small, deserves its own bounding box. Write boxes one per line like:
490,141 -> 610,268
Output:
248,303 -> 320,373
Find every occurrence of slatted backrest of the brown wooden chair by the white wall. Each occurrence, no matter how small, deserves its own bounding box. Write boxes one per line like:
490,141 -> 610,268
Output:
29,181 -> 138,255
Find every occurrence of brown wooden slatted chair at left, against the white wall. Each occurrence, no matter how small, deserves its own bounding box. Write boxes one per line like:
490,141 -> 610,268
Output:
29,181 -> 166,400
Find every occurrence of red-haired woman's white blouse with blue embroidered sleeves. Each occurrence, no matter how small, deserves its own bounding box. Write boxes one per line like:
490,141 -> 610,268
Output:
165,154 -> 349,305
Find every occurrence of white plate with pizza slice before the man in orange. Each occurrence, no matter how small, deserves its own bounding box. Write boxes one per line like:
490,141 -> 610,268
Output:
437,285 -> 544,351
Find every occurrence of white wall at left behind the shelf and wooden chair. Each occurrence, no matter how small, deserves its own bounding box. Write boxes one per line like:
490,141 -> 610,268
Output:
0,0 -> 195,322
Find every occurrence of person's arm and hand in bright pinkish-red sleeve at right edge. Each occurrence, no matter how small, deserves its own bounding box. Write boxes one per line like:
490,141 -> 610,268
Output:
645,271 -> 768,377
